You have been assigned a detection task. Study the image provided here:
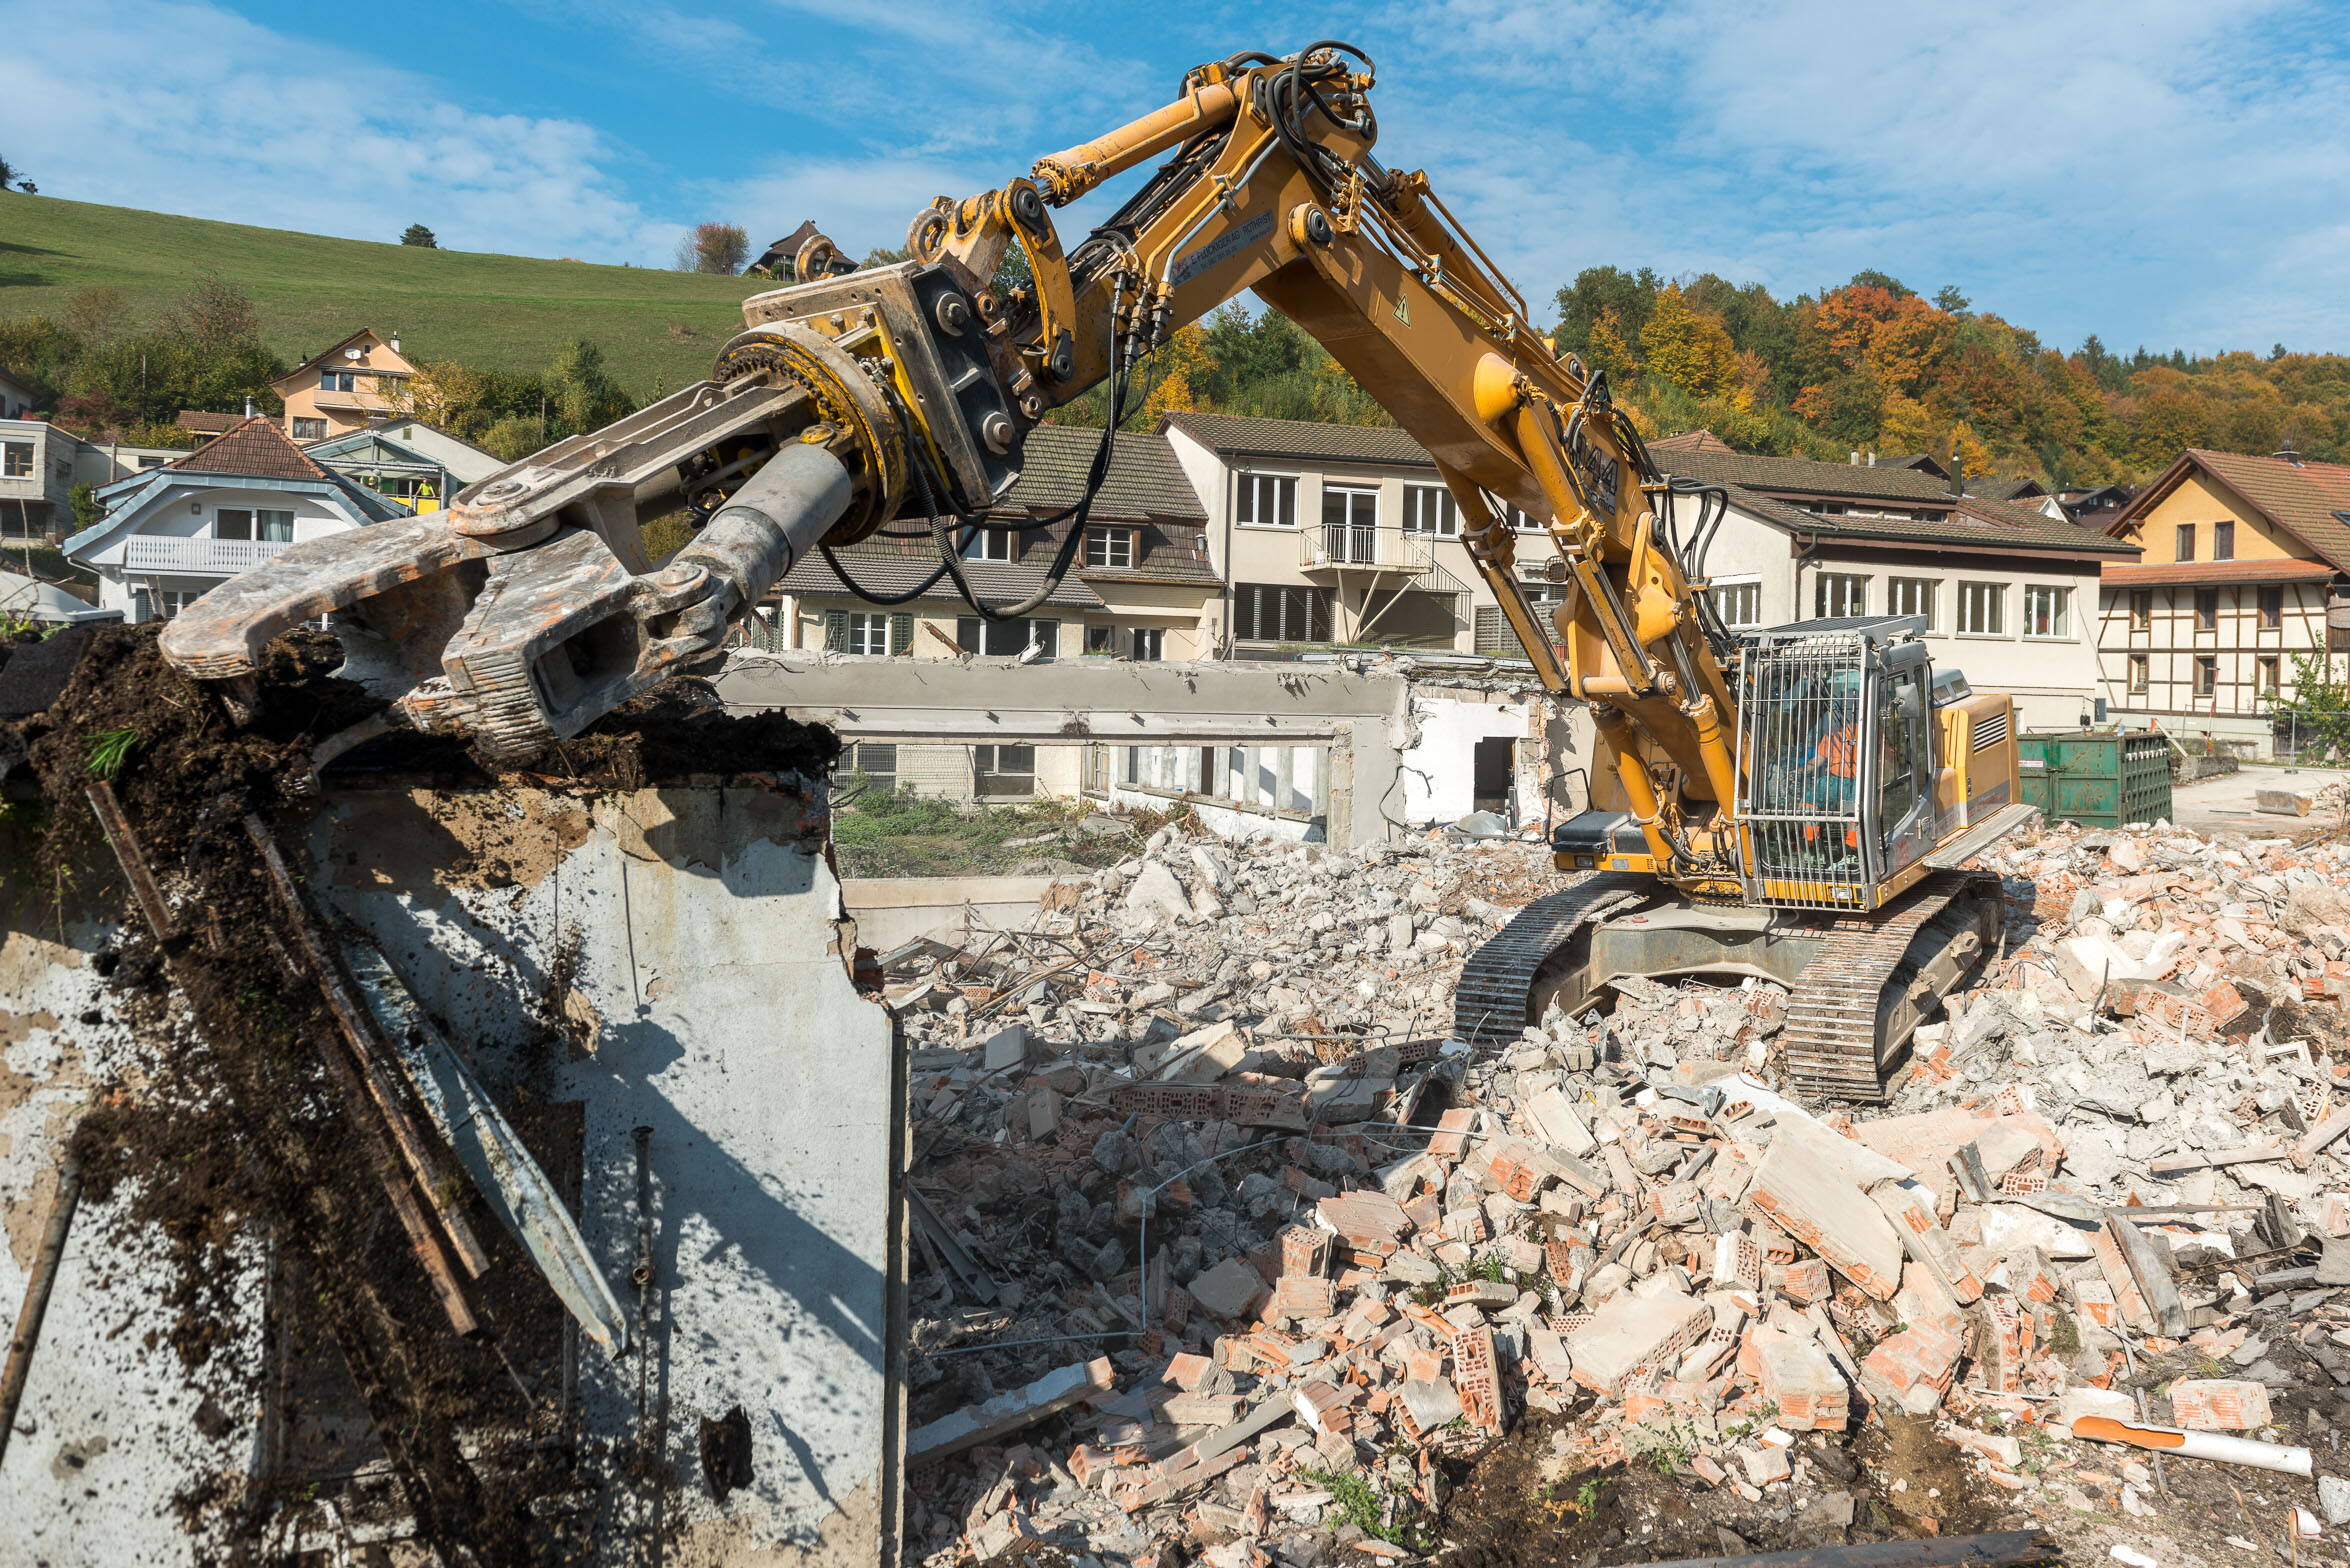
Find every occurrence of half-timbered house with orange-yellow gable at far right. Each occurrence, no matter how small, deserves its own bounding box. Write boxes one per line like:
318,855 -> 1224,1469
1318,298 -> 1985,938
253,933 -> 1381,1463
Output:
2099,451 -> 2350,757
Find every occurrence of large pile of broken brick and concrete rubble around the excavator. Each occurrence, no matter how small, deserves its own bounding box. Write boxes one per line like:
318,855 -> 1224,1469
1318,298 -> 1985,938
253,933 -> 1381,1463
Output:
893,827 -> 2350,1568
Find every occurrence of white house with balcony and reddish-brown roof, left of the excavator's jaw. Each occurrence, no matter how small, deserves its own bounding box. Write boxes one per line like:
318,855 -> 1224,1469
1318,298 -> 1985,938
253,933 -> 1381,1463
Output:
63,416 -> 409,621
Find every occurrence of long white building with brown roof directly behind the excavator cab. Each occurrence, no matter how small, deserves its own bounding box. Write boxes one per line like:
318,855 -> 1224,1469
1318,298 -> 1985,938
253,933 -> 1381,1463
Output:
1650,433 -> 2136,729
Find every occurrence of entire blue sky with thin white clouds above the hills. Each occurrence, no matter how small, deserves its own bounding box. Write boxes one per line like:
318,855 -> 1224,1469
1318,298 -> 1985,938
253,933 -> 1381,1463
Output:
0,0 -> 2350,350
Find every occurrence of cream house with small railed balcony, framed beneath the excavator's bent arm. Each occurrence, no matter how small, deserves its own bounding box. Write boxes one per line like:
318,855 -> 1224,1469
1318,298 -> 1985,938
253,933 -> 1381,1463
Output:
1159,411 -> 1516,658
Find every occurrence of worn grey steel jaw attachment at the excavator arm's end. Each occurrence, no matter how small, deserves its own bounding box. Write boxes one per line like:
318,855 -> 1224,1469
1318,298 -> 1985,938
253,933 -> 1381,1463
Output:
160,322 -> 905,762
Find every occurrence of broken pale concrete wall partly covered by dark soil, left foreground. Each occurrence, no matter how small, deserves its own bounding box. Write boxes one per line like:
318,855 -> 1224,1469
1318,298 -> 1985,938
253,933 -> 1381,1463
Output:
0,780 -> 902,1568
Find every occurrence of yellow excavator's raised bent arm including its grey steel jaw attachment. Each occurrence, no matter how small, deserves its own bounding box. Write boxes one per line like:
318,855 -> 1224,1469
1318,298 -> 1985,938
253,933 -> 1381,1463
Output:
165,45 -> 1741,898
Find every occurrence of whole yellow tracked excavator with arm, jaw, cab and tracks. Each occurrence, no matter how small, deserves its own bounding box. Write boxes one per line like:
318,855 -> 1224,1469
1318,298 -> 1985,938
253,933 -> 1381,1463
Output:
162,42 -> 2028,1098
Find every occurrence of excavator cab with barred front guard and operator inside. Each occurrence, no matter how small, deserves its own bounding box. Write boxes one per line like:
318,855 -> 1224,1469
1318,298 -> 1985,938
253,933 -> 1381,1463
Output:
1737,616 -> 1936,910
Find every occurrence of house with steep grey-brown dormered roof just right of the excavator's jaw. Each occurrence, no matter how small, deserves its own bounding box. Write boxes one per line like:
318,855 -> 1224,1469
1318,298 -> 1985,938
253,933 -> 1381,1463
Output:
759,425 -> 1222,799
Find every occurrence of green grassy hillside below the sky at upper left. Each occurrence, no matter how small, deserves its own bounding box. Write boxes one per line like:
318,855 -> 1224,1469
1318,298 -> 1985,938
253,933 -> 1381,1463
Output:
0,193 -> 776,397
